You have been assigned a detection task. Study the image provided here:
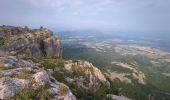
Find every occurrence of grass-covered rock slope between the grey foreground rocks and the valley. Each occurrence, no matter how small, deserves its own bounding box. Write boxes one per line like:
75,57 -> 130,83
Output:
34,58 -> 111,100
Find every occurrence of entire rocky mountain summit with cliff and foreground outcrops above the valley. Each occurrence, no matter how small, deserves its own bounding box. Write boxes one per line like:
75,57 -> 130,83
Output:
0,26 -> 129,100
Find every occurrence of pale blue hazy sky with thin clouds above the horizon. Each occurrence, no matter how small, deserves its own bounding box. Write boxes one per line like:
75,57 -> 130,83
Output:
0,0 -> 170,33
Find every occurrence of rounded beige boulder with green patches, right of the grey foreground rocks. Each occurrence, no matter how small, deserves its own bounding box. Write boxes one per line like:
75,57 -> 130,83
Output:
64,60 -> 110,92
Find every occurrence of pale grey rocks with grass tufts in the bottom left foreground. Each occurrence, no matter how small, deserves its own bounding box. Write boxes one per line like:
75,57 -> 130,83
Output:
0,56 -> 76,100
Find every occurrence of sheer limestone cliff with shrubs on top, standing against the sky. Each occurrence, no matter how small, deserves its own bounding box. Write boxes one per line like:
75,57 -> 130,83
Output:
0,26 -> 61,57
